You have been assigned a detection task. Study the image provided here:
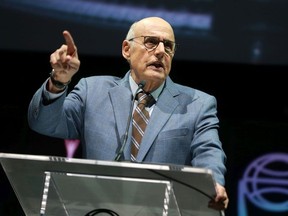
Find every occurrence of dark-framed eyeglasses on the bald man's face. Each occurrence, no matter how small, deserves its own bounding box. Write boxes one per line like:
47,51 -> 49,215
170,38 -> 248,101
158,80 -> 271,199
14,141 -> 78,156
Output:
128,36 -> 176,55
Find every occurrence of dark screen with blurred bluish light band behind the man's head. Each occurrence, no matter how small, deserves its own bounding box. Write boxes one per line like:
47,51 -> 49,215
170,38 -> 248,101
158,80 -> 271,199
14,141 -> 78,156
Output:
0,0 -> 288,65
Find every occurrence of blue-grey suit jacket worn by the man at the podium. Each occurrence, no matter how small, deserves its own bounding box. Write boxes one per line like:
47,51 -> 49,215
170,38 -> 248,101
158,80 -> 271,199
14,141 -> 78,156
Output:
28,72 -> 226,185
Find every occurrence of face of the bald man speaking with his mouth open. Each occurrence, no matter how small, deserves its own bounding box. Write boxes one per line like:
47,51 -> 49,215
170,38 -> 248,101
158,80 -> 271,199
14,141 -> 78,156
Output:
122,20 -> 175,92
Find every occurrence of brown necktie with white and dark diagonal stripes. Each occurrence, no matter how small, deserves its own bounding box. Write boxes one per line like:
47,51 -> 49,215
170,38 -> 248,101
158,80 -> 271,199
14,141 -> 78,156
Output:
131,92 -> 153,161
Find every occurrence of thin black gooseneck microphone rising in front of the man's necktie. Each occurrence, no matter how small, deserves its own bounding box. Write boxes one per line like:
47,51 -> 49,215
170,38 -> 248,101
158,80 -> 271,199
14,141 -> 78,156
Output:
114,80 -> 146,161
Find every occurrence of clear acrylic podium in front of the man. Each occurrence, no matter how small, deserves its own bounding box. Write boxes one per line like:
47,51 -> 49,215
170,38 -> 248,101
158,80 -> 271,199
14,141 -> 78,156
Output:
0,153 -> 221,216
